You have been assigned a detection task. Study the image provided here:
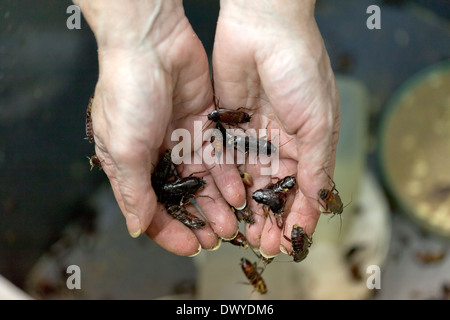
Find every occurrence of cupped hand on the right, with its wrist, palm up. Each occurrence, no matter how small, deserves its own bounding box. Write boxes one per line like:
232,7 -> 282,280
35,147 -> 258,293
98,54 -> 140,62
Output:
211,0 -> 340,257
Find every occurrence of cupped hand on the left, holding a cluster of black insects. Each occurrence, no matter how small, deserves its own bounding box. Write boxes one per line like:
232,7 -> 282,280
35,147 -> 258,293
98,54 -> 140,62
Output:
74,0 -> 241,256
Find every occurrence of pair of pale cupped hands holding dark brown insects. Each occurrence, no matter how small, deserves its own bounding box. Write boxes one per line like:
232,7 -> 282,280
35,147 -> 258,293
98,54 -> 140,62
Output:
74,0 -> 340,257
